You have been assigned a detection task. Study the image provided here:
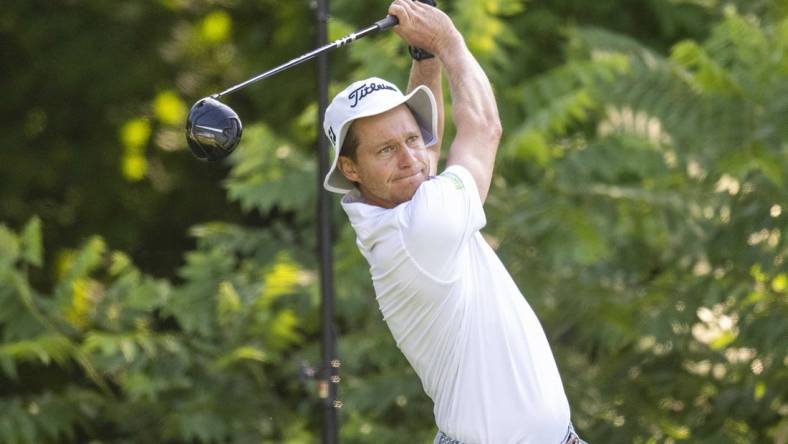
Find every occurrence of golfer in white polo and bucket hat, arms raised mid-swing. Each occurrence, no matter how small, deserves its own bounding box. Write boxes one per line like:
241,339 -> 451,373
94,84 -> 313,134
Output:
324,0 -> 582,444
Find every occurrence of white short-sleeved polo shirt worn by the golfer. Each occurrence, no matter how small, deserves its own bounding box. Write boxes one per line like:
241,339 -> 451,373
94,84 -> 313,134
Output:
342,165 -> 569,444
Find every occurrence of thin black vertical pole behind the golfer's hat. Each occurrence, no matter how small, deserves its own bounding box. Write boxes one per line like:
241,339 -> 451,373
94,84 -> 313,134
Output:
317,0 -> 339,444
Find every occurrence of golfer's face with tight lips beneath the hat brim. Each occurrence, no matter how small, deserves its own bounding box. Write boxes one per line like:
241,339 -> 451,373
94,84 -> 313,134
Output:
338,105 -> 430,208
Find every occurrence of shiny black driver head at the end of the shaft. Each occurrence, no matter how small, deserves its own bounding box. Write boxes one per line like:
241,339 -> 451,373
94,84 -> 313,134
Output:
186,97 -> 243,162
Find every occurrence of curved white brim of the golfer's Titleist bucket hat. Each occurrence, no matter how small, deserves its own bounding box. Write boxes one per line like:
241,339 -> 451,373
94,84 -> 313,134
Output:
323,85 -> 438,194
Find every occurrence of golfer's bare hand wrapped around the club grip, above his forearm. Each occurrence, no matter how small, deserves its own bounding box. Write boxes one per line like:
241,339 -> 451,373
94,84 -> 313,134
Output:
389,0 -> 462,56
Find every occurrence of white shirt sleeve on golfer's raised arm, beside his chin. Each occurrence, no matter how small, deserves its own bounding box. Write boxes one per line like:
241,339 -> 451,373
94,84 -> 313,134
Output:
399,165 -> 487,280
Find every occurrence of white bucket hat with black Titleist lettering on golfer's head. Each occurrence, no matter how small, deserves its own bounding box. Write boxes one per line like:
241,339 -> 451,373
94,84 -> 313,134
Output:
323,77 -> 438,194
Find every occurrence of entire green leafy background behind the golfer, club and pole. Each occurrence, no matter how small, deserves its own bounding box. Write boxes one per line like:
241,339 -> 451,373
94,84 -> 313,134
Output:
0,0 -> 788,444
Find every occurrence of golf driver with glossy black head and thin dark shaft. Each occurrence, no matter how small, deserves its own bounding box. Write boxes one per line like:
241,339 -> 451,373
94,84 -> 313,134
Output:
186,15 -> 399,162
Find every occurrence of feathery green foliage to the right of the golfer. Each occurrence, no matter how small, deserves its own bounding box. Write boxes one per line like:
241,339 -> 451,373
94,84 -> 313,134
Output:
488,5 -> 788,443
